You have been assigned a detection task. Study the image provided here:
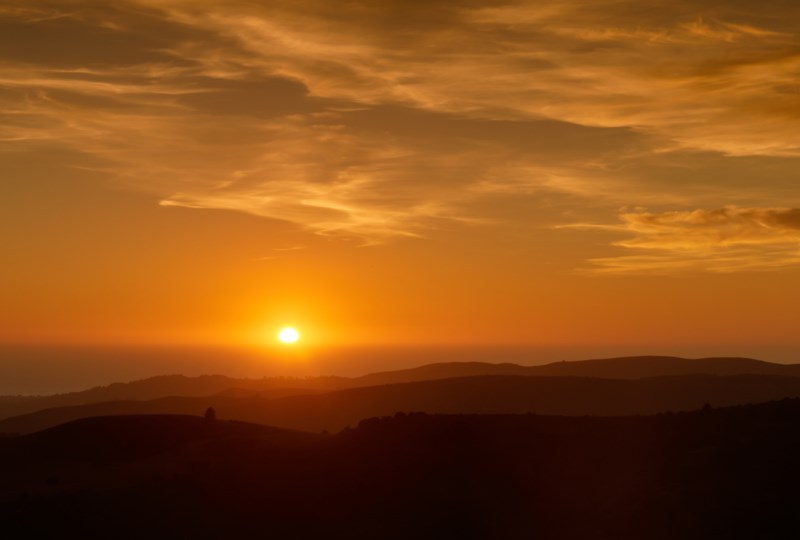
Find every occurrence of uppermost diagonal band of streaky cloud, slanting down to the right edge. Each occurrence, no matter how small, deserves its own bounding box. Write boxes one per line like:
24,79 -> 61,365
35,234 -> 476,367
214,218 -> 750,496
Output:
142,0 -> 800,155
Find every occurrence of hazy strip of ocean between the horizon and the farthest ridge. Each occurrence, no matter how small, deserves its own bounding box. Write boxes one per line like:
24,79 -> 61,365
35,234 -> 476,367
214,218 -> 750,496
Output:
0,345 -> 800,395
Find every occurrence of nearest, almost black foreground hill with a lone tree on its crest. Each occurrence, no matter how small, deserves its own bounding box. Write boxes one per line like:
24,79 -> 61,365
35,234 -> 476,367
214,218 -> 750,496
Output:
0,400 -> 800,540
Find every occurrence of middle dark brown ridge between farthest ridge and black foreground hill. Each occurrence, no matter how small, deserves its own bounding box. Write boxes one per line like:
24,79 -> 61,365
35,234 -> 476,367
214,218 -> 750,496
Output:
0,375 -> 800,433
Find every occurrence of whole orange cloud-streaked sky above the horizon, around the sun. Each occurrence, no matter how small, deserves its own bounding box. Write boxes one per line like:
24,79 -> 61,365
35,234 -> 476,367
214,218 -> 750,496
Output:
0,0 -> 800,378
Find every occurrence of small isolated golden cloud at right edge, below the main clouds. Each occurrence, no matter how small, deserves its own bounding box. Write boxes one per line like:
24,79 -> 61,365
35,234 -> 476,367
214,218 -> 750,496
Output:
575,207 -> 800,274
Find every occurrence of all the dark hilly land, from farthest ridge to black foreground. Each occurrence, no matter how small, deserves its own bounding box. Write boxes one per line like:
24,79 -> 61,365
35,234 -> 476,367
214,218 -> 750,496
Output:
0,357 -> 800,539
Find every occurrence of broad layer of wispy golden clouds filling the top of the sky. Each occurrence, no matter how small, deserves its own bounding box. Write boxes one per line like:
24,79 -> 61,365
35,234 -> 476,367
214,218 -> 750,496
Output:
0,0 -> 800,245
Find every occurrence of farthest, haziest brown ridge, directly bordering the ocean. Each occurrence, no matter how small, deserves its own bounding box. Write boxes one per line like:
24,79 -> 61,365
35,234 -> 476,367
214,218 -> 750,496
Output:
0,356 -> 800,419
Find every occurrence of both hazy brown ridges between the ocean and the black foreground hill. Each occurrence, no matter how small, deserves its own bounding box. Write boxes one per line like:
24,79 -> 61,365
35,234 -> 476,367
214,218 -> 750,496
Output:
0,356 -> 800,433
